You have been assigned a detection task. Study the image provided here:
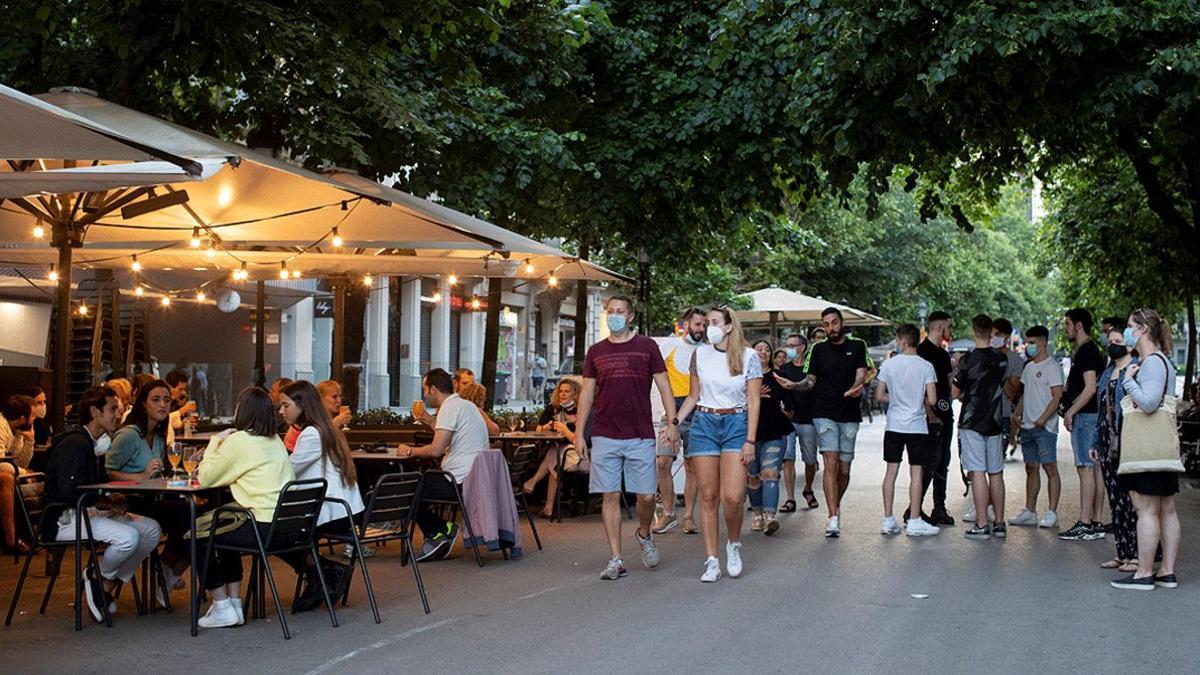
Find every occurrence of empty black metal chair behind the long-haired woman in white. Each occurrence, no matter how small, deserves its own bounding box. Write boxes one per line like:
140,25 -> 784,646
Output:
323,471 -> 430,623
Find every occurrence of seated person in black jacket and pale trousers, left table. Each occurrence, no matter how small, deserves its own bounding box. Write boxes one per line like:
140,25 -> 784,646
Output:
44,387 -> 162,621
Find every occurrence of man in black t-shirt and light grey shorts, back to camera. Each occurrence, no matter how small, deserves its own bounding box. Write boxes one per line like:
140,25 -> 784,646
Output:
950,315 -> 1008,539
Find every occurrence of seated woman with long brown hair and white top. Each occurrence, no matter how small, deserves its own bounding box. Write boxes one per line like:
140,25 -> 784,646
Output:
280,380 -> 366,610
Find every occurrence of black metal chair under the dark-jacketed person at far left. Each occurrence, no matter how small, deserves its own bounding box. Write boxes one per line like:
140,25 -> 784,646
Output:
4,473 -> 123,631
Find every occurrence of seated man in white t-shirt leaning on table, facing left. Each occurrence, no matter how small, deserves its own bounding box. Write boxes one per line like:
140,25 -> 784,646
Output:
397,368 -> 488,562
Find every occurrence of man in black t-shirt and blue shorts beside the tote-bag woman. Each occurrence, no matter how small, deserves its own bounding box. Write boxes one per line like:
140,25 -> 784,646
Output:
1058,307 -> 1106,540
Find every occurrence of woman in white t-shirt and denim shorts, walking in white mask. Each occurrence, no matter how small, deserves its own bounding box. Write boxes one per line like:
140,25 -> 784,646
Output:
679,306 -> 762,583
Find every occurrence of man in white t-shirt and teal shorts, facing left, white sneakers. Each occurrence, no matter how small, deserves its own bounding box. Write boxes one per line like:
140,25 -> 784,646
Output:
1009,325 -> 1062,527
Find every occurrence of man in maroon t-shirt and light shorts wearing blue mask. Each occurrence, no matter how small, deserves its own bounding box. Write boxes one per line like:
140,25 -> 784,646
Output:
575,295 -> 679,580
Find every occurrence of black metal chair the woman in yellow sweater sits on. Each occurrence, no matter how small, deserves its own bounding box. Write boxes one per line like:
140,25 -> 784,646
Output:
196,478 -> 338,640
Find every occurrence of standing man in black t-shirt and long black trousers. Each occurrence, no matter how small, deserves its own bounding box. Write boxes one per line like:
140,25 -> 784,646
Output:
905,311 -> 954,526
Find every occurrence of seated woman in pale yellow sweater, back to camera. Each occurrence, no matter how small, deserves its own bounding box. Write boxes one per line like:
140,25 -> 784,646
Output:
197,387 -> 306,628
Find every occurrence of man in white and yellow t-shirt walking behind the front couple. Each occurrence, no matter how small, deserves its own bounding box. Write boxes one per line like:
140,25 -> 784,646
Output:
650,307 -> 708,534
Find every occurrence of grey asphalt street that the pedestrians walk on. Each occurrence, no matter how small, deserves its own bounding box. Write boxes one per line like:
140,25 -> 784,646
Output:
0,418 -> 1200,675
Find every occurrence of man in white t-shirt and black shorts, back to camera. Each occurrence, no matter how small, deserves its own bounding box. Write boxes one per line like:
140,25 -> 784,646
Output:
877,323 -> 938,537
